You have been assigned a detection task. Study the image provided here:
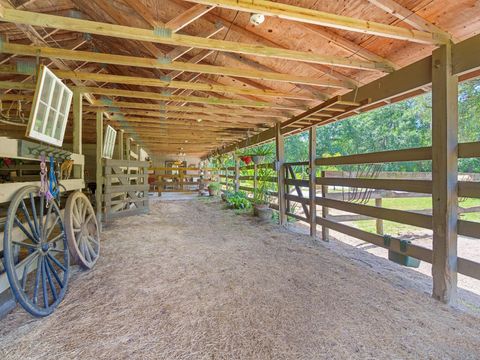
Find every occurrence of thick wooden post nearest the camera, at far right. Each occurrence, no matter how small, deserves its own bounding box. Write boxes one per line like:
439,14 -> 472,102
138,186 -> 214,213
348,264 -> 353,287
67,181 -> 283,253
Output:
432,43 -> 458,303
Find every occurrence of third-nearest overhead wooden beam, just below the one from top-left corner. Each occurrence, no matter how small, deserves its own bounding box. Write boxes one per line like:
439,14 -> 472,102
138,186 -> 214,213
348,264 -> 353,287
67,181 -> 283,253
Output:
0,42 -> 352,88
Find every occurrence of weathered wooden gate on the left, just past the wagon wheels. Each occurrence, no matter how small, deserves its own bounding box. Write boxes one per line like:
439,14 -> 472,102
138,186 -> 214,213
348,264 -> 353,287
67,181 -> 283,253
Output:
103,159 -> 149,222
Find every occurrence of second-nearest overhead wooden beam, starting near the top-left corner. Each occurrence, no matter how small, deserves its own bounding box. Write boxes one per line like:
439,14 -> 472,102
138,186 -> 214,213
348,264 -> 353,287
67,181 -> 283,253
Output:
0,7 -> 392,72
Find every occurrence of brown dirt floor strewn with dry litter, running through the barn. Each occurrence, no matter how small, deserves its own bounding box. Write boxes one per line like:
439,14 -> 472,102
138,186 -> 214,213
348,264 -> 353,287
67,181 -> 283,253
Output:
0,200 -> 480,360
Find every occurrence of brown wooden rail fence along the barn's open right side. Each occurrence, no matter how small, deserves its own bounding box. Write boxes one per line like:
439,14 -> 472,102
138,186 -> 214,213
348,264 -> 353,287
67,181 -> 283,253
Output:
219,142 -> 480,279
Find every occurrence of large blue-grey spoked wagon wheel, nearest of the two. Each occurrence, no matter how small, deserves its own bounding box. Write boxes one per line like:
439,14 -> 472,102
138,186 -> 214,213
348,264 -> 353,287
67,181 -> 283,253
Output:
3,186 -> 69,316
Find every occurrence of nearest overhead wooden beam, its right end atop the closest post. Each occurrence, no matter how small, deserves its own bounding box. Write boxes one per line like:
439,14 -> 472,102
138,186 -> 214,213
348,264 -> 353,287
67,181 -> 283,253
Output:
188,0 -> 449,45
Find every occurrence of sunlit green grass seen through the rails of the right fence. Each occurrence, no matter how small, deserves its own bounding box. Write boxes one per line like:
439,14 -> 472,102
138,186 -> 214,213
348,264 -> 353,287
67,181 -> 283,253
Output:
348,198 -> 480,235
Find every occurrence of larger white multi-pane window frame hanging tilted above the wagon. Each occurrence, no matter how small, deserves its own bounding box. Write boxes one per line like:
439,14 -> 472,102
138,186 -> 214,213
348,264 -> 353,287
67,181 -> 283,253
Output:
26,65 -> 73,146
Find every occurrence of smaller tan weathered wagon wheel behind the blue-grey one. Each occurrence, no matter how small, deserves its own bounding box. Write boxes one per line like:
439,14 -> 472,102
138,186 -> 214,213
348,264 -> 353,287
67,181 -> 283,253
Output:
64,191 -> 100,269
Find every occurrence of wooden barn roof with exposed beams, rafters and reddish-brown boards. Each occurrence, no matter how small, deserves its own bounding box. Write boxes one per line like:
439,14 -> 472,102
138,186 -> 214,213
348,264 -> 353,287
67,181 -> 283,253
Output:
0,0 -> 480,156
